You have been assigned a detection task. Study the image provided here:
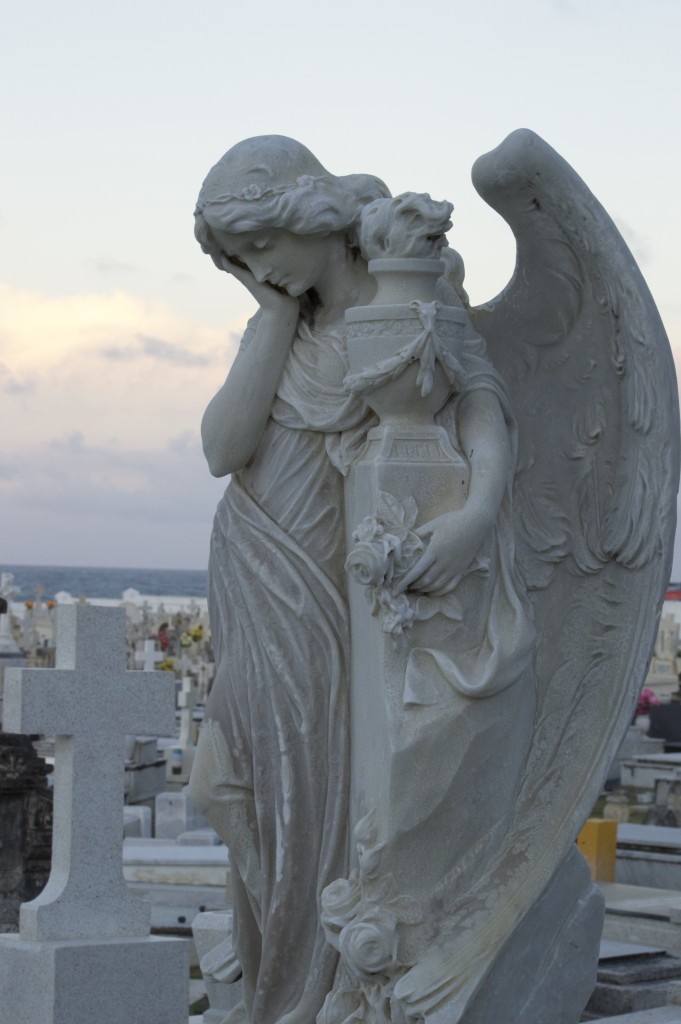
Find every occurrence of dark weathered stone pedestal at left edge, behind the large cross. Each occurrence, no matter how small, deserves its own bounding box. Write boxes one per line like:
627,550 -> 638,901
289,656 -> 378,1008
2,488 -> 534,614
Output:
0,733 -> 52,932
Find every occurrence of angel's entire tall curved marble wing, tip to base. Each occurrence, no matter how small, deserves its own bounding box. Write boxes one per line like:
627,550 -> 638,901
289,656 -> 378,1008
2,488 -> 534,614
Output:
398,131 -> 679,1024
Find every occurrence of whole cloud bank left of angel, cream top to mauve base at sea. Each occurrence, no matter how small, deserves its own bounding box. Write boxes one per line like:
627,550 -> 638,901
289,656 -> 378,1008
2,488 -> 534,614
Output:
0,285 -> 241,567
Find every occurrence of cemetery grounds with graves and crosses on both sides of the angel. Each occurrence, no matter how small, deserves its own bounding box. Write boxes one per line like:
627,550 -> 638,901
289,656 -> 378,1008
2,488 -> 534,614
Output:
0,572 -> 681,1024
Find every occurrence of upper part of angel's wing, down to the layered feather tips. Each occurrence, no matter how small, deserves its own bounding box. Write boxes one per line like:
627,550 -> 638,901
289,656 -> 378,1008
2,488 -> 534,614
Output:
471,131 -> 678,587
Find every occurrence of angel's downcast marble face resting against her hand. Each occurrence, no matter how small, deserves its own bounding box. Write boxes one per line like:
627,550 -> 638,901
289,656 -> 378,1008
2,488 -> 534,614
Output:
213,227 -> 331,298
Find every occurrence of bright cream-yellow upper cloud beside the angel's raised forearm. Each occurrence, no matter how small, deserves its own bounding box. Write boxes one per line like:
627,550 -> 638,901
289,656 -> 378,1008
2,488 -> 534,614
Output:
0,285 -> 243,456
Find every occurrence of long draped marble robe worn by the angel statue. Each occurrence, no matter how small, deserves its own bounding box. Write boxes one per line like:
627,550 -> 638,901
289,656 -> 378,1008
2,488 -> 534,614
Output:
191,323 -> 530,1024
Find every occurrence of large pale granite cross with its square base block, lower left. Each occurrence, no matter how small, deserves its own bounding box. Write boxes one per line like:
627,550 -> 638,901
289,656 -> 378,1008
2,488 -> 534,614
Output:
0,604 -> 188,1024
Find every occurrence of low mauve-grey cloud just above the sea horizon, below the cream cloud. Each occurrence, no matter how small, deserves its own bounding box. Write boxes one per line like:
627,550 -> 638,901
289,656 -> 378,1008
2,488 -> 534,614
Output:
0,423 -> 225,568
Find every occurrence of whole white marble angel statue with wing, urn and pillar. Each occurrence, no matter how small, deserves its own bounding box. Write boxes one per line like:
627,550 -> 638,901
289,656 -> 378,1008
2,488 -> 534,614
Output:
190,131 -> 679,1024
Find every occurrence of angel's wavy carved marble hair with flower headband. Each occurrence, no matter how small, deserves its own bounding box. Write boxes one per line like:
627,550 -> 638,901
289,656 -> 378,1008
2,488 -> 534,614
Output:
195,135 -> 390,269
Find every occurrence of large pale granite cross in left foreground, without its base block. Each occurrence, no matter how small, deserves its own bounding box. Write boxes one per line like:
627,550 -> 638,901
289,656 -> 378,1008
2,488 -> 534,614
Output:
4,605 -> 175,940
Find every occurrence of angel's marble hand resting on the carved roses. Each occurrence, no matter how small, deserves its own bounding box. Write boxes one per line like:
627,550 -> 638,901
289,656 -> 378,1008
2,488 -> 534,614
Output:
393,508 -> 491,597
